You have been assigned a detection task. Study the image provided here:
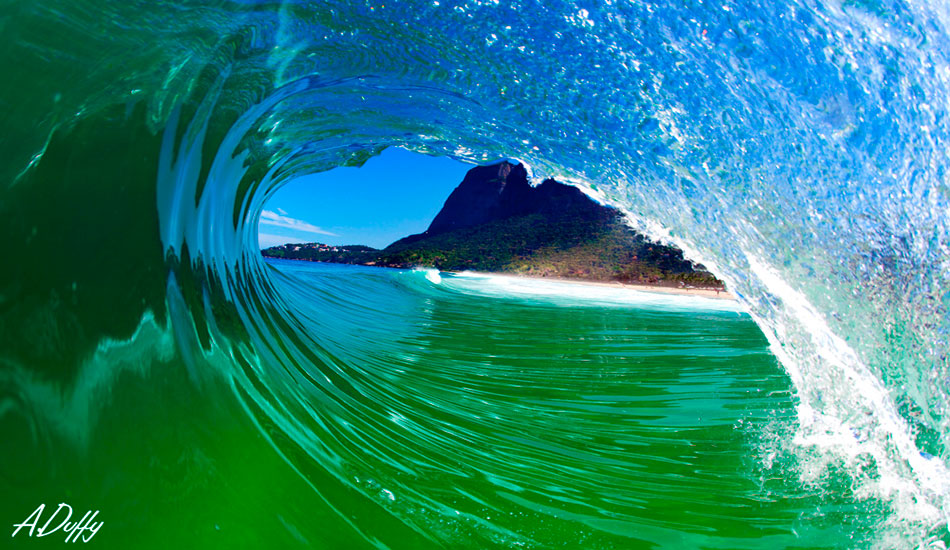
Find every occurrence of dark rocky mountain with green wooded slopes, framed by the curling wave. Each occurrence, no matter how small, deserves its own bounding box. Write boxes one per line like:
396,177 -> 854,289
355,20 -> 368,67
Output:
261,162 -> 732,297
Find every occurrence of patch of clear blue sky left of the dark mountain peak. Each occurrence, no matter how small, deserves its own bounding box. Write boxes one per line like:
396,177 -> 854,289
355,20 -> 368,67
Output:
258,148 -> 472,248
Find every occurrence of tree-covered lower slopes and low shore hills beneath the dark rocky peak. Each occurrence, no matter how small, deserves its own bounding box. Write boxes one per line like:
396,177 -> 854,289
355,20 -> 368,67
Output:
263,207 -> 723,288
